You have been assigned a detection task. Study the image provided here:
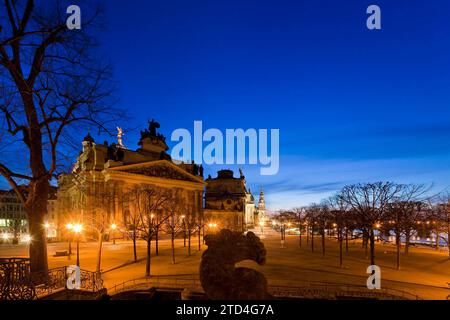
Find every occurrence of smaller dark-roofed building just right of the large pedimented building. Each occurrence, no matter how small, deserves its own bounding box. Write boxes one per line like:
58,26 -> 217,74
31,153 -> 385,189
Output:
204,170 -> 255,231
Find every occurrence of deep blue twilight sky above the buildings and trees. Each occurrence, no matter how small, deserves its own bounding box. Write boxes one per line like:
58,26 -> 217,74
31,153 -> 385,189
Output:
3,0 -> 450,209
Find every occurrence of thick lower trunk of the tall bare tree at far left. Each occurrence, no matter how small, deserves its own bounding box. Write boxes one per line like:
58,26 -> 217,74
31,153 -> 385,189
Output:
25,178 -> 49,273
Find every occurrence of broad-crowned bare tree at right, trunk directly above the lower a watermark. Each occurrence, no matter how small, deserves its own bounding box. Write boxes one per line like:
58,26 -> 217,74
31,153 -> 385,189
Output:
339,182 -> 403,265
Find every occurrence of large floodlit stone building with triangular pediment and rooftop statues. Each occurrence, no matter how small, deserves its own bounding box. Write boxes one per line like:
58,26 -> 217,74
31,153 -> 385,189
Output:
57,120 -> 205,238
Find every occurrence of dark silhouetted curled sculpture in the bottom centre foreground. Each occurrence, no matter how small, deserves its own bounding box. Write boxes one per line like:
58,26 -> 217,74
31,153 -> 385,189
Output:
200,229 -> 272,300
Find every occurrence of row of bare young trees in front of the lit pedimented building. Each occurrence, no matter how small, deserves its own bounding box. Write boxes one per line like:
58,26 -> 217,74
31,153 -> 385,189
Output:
85,185 -> 204,276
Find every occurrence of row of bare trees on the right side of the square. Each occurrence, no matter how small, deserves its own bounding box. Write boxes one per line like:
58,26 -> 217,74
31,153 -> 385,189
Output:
277,182 -> 450,269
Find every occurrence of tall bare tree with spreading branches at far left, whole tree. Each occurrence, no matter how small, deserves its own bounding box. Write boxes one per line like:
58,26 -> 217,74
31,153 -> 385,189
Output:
0,0 -> 121,272
